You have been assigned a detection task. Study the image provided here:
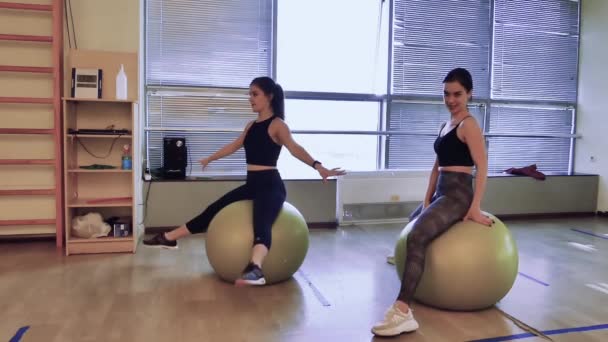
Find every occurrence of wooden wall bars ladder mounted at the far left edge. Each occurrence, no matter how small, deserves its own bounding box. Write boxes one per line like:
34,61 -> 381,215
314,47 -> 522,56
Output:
0,0 -> 64,248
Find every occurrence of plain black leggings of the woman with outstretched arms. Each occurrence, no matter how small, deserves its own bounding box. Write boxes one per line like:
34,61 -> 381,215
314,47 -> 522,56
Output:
186,170 -> 287,249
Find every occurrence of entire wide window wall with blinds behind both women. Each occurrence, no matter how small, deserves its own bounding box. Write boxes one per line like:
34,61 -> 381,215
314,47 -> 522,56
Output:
145,0 -> 579,179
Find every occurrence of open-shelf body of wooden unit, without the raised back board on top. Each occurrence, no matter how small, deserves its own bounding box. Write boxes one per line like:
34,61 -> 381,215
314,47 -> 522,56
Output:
64,98 -> 138,255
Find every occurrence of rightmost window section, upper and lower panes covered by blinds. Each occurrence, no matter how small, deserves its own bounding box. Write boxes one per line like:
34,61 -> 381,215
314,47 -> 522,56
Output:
486,0 -> 579,172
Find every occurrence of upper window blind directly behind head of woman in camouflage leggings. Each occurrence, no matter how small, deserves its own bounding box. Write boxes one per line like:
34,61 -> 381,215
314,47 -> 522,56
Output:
392,0 -> 492,98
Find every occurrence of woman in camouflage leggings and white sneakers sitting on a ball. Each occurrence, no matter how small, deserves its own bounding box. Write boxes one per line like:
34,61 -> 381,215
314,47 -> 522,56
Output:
372,68 -> 492,336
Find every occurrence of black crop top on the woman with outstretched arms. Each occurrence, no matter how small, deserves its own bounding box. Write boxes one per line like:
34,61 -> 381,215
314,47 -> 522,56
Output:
243,116 -> 282,166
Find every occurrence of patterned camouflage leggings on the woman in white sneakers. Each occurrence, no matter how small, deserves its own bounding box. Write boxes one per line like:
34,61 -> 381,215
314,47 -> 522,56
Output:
397,172 -> 473,304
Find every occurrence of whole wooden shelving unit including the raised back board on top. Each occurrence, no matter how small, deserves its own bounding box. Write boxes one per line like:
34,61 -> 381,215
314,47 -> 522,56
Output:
63,50 -> 141,255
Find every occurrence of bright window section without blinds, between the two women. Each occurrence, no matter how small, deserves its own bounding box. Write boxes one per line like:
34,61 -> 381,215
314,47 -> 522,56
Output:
277,0 -> 388,179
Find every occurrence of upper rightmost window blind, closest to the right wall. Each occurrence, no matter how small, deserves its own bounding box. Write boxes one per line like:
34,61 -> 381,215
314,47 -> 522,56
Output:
492,0 -> 579,103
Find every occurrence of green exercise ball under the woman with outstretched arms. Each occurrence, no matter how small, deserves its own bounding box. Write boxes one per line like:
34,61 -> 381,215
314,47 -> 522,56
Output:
205,200 -> 308,284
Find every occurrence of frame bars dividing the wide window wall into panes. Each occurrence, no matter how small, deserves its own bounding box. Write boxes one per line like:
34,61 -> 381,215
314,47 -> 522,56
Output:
141,0 -> 581,180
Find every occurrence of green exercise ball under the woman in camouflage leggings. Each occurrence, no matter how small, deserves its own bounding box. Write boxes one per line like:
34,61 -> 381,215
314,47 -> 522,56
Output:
395,213 -> 519,311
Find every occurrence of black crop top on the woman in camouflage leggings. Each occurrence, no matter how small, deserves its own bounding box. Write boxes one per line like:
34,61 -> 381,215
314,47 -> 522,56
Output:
433,116 -> 474,166
